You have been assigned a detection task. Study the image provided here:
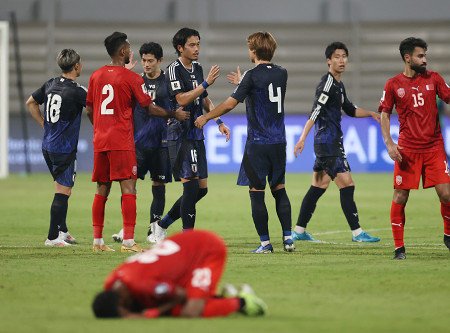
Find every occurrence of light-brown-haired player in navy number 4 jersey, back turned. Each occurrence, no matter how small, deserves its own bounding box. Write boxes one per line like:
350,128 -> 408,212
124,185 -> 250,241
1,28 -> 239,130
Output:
195,32 -> 295,253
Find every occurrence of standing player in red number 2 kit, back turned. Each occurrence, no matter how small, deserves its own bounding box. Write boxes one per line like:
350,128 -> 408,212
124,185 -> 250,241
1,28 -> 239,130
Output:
86,32 -> 189,252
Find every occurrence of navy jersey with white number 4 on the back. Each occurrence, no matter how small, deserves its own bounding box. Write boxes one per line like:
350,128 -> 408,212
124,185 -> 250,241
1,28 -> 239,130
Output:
231,64 -> 287,144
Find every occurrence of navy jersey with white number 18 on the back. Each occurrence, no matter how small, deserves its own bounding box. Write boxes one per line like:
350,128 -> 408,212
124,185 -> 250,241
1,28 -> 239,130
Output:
32,76 -> 87,154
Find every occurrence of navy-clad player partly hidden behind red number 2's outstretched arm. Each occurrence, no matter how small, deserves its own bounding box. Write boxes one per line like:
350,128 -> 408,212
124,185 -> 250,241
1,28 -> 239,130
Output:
112,42 -> 172,242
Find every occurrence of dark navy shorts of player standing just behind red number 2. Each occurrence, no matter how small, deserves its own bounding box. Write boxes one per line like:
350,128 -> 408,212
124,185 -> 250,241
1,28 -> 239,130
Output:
136,146 -> 172,183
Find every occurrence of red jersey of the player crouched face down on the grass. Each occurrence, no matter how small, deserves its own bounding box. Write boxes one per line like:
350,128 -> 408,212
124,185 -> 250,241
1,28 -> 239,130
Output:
105,230 -> 226,308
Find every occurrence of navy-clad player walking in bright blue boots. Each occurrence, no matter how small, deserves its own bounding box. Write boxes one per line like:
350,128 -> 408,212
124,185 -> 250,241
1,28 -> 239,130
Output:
292,42 -> 380,242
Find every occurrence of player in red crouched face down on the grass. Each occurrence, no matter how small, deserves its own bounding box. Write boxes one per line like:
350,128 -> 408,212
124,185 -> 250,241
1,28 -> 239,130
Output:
92,230 -> 267,318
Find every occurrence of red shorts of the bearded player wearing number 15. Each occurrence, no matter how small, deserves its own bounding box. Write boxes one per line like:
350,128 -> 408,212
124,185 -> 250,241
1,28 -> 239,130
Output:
394,149 -> 450,190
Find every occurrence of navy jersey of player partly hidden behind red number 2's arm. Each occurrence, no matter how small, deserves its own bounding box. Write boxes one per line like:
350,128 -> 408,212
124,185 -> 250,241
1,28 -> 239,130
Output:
134,71 -> 171,148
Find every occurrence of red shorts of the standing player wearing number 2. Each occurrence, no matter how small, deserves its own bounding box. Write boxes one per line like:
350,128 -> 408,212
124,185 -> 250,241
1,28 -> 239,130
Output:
92,150 -> 137,183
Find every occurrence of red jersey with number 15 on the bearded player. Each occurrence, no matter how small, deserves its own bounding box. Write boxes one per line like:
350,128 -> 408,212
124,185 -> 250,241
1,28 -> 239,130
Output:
378,71 -> 450,152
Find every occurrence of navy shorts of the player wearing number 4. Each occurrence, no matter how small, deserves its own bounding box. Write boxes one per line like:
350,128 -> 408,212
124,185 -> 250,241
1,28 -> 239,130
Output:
237,143 -> 286,190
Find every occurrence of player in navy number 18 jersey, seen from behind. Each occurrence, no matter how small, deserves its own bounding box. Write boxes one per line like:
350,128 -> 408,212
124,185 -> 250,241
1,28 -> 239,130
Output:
26,49 -> 87,246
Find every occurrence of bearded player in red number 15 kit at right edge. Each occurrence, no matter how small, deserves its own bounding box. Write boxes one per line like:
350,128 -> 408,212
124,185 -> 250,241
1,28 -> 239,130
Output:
378,37 -> 450,260
